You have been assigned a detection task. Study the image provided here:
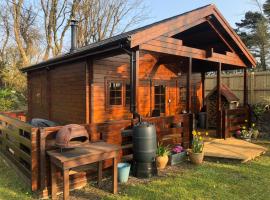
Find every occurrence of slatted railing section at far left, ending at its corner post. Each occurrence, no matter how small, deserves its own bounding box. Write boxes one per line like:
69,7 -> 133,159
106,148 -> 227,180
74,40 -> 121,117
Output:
0,114 -> 39,191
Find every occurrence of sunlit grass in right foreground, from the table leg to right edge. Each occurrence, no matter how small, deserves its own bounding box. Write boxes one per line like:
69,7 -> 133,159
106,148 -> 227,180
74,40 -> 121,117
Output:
104,143 -> 270,200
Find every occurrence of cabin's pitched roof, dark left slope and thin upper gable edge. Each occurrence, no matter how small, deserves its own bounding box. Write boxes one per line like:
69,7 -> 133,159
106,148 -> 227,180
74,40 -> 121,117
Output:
22,4 -> 255,72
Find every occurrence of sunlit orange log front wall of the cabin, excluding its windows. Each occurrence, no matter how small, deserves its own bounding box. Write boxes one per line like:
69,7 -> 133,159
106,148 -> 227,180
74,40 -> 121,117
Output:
90,51 -> 202,123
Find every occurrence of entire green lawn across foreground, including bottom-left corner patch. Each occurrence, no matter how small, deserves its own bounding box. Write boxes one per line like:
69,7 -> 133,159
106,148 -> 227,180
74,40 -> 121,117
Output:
0,142 -> 270,200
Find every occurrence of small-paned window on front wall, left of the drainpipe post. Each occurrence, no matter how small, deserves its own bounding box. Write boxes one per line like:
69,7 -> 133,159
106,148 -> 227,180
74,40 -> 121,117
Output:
108,81 -> 123,106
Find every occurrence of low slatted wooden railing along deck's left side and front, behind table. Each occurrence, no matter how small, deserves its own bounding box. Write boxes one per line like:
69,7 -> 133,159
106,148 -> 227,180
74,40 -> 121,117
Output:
0,114 -> 193,197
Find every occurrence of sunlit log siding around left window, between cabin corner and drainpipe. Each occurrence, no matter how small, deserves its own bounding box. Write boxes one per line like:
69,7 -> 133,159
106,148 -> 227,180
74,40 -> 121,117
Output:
92,54 -> 131,123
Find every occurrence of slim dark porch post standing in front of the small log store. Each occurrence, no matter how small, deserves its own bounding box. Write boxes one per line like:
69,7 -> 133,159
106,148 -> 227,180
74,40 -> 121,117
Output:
217,63 -> 222,138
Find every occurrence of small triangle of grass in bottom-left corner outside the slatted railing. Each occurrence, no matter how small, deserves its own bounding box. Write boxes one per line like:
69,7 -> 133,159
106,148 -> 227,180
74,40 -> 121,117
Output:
0,157 -> 32,200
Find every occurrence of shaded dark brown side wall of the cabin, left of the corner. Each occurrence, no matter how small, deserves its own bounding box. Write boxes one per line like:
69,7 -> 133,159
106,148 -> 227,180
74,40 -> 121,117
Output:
28,61 -> 86,124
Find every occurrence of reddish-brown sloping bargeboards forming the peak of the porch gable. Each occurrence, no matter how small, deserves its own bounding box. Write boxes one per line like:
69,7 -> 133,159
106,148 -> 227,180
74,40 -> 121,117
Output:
130,4 -> 256,66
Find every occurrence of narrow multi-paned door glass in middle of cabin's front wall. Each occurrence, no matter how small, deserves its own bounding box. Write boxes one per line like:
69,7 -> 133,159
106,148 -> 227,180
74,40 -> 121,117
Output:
155,85 -> 166,113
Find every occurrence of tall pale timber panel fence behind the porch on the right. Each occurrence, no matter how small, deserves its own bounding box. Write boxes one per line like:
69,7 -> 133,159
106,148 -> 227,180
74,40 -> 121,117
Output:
205,72 -> 270,104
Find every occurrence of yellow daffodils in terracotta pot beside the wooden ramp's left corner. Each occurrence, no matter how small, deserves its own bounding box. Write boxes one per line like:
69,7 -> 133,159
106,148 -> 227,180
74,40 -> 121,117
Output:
189,130 -> 208,165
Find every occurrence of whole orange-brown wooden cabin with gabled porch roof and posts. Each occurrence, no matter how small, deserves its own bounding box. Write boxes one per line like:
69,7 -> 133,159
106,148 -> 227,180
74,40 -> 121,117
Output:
22,4 -> 256,140
